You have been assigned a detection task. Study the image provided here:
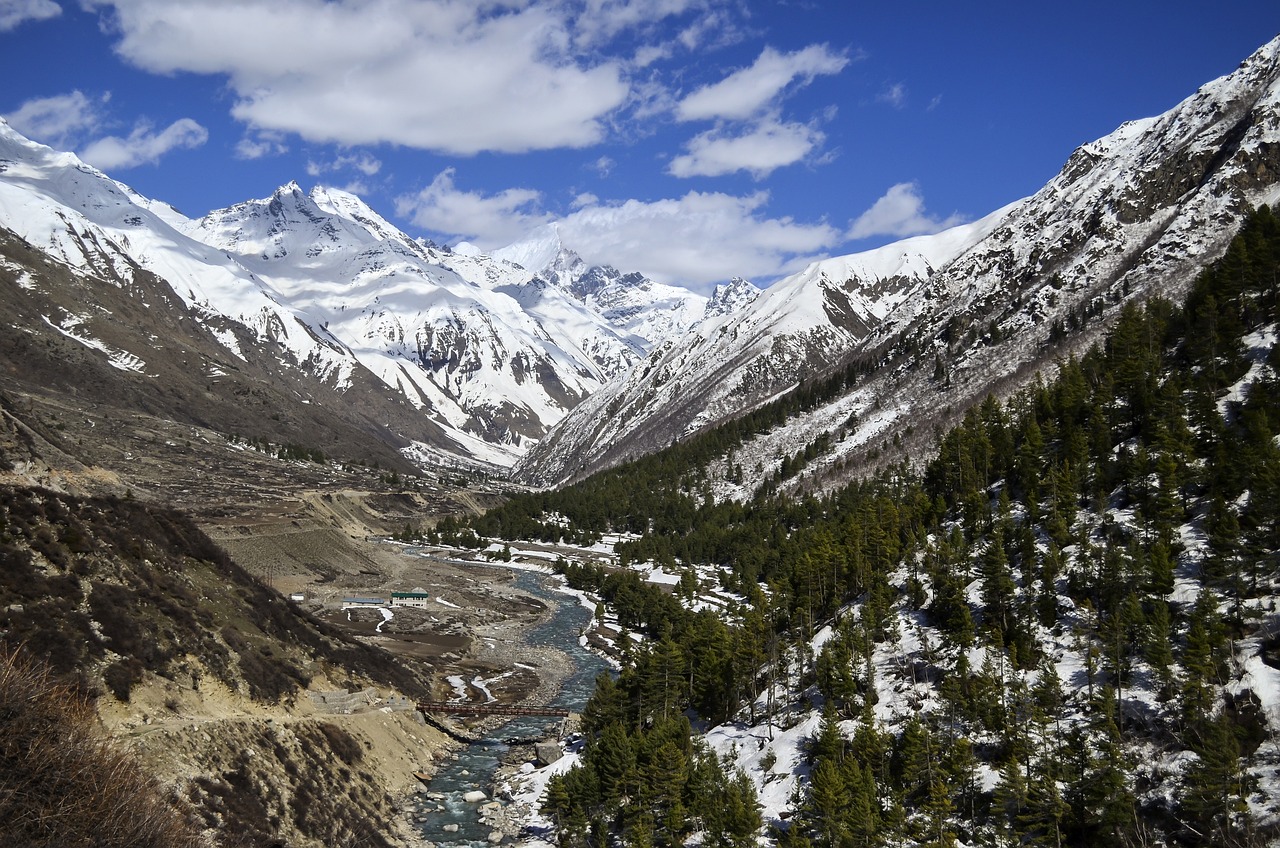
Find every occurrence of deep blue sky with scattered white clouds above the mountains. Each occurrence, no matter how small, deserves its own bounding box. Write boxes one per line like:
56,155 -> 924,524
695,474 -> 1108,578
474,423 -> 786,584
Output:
0,0 -> 1280,289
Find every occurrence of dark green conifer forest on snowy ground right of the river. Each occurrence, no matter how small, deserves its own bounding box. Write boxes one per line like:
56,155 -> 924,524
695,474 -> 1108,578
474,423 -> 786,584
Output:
465,208 -> 1280,848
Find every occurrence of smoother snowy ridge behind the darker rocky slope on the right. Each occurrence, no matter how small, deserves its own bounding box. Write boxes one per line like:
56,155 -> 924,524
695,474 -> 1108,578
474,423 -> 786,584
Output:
521,209 -> 1009,483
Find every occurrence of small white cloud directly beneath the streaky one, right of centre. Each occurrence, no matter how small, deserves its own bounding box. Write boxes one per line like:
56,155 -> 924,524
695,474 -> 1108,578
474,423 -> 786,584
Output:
667,119 -> 824,179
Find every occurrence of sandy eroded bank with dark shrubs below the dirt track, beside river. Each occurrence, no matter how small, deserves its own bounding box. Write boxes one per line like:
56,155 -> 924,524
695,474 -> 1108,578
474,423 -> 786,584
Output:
115,708 -> 453,848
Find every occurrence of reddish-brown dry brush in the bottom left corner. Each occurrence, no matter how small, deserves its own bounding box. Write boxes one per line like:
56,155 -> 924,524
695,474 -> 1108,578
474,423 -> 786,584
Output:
0,648 -> 204,848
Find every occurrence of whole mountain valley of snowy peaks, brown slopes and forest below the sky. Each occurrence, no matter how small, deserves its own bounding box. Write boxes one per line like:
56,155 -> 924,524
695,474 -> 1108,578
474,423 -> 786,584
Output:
0,29 -> 1280,848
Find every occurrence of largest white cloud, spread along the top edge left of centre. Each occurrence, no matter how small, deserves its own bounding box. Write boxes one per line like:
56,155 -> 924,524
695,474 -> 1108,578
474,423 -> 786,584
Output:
84,0 -> 637,155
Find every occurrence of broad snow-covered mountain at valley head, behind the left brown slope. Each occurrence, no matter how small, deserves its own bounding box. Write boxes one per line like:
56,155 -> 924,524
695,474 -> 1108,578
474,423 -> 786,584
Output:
182,183 -> 637,462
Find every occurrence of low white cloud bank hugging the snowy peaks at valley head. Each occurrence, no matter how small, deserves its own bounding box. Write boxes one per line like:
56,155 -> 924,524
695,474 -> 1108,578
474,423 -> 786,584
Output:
397,169 -> 841,287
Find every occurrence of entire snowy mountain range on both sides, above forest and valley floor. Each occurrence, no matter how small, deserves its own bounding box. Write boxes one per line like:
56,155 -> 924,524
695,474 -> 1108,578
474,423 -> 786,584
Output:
0,34 -> 1280,484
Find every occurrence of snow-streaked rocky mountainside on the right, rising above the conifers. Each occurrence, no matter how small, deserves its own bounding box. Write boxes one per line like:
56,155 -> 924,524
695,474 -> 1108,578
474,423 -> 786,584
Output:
517,38 -> 1280,484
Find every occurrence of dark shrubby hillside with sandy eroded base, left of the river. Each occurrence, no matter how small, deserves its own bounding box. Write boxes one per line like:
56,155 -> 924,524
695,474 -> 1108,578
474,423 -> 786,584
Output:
0,484 -> 448,845
